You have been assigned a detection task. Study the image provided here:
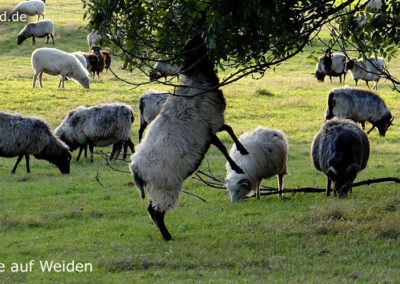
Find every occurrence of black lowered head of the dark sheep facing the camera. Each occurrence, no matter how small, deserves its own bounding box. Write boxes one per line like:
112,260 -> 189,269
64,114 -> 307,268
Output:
326,163 -> 361,198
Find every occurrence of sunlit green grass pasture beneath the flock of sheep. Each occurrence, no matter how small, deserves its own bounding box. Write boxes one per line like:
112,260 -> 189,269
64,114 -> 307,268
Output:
0,0 -> 400,283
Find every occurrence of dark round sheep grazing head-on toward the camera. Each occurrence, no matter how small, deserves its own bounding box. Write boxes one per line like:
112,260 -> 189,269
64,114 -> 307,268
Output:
311,119 -> 370,198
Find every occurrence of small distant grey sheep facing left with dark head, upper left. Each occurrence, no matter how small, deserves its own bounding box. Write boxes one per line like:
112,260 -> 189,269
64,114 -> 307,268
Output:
17,20 -> 54,45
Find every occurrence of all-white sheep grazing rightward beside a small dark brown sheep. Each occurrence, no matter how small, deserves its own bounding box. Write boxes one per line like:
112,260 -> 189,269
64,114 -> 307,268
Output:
31,48 -> 90,89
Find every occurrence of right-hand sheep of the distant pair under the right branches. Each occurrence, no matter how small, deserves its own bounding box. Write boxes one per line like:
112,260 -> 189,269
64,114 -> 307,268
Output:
346,57 -> 386,90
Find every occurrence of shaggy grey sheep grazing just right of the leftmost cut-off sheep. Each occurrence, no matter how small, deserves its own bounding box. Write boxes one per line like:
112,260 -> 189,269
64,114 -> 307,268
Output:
56,103 -> 134,162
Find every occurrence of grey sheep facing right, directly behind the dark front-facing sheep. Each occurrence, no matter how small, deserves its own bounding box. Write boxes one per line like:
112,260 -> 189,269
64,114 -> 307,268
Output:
325,88 -> 394,136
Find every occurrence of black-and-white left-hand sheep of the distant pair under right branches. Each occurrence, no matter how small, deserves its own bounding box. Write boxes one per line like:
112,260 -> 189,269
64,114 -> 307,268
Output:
315,53 -> 347,83
